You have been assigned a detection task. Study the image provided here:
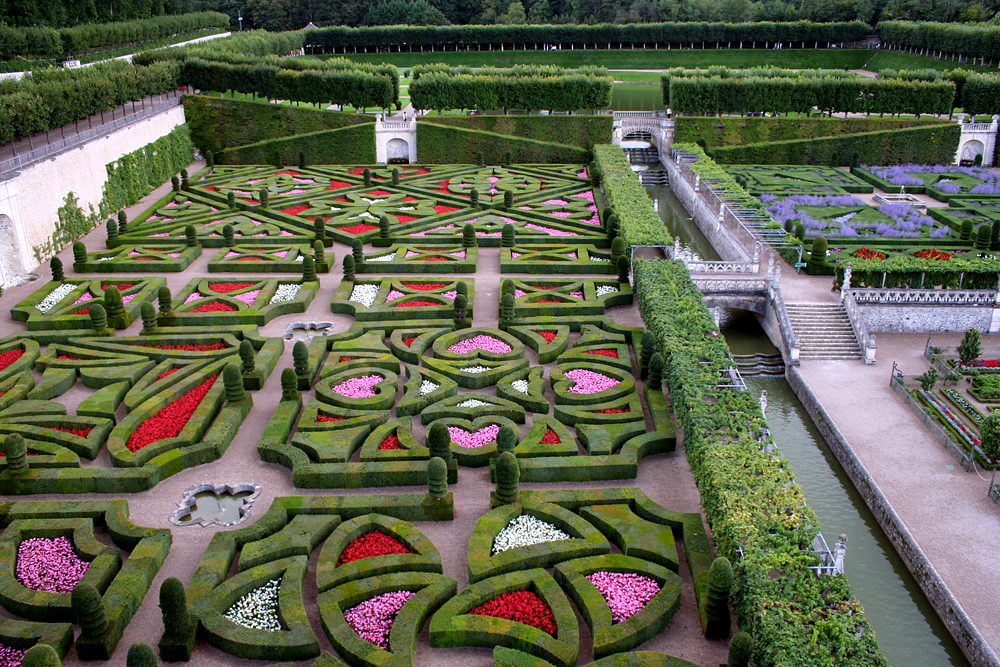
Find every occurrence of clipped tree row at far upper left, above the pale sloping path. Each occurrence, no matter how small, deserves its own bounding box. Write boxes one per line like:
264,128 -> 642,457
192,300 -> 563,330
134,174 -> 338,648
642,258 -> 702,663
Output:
0,12 -> 229,60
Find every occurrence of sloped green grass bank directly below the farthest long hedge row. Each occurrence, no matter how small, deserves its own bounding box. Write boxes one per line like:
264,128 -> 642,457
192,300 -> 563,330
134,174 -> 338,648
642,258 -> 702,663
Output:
320,49 -> 872,69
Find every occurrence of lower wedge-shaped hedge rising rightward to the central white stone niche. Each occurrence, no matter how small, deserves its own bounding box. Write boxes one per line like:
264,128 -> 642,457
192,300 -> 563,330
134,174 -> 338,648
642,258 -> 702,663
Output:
216,123 -> 375,165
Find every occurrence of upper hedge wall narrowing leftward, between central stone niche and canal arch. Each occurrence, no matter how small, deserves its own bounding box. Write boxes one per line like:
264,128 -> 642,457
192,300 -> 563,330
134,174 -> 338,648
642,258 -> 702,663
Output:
420,115 -> 615,148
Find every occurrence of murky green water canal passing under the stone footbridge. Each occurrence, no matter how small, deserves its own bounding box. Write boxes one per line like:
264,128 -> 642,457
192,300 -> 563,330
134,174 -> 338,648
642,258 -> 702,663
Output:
647,179 -> 969,667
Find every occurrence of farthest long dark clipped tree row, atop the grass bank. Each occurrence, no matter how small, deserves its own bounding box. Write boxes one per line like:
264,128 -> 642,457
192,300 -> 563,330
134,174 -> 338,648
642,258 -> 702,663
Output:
304,21 -> 871,49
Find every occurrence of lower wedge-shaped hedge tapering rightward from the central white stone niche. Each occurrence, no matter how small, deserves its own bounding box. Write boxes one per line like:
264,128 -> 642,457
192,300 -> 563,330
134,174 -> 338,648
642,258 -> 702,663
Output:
414,119 -> 590,164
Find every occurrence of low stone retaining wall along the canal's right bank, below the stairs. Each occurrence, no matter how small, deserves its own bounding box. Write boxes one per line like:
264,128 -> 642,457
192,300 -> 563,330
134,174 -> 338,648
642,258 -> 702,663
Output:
786,368 -> 1000,667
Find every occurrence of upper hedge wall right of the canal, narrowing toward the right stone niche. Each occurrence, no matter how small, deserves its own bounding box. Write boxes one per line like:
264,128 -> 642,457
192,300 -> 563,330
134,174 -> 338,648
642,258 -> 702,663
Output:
674,116 -> 941,150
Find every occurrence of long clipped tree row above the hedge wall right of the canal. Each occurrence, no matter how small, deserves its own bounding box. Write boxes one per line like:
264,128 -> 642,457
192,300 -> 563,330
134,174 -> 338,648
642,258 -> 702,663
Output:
661,72 -> 955,114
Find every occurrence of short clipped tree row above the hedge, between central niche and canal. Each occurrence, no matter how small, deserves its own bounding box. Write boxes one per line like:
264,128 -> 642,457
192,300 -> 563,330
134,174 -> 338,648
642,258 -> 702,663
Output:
410,70 -> 613,111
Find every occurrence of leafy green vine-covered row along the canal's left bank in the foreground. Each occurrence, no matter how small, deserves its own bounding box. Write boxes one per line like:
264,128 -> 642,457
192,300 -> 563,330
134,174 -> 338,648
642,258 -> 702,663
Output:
635,260 -> 888,667
